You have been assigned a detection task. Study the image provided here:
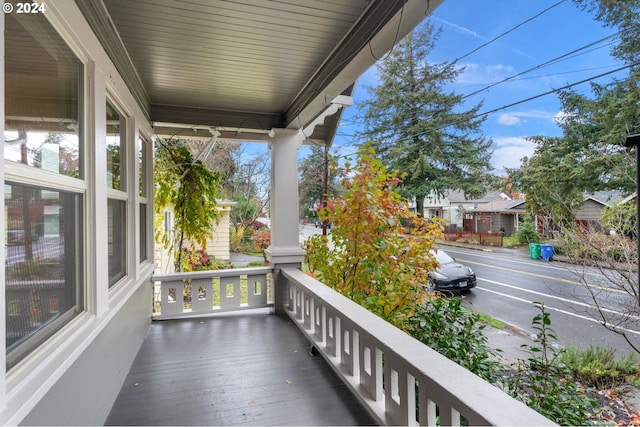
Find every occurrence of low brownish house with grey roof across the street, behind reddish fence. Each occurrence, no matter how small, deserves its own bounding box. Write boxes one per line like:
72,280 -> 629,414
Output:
470,199 -> 525,235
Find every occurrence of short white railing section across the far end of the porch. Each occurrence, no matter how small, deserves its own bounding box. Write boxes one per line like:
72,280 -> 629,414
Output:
153,267 -> 273,320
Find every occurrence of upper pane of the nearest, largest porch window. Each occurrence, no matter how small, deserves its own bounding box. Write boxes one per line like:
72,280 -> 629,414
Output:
4,13 -> 83,177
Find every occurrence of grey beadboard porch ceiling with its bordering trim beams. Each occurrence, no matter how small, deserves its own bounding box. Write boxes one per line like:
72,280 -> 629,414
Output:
76,0 -> 442,144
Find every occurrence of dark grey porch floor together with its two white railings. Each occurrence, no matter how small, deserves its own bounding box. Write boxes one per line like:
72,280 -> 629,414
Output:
106,267 -> 551,425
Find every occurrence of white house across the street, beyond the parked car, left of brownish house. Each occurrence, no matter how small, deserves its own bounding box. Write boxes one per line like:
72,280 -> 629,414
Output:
424,190 -> 508,231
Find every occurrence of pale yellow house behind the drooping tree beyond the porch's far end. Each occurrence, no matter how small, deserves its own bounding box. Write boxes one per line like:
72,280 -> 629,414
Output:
156,201 -> 236,274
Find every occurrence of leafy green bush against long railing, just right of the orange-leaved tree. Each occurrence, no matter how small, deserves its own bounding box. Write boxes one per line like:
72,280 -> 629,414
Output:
408,294 -> 501,382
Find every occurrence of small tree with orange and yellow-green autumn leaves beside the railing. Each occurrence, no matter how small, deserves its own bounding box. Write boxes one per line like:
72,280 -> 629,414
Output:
306,146 -> 441,329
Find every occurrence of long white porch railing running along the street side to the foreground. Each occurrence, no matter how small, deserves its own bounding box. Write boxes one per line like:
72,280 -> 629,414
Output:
281,269 -> 554,426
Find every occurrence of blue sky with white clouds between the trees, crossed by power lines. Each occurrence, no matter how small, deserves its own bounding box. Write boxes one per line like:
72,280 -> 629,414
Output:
318,0 -> 623,176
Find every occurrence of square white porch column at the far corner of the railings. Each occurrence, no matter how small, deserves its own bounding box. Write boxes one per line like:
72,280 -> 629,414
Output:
265,129 -> 305,314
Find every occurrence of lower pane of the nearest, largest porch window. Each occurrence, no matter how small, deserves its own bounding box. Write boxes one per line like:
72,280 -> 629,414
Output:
4,183 -> 84,368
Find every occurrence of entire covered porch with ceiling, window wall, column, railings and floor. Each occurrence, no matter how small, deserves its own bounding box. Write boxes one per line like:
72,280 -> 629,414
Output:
0,0 -> 548,425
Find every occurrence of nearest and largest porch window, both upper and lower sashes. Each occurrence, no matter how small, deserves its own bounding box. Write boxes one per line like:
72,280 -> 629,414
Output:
3,13 -> 86,369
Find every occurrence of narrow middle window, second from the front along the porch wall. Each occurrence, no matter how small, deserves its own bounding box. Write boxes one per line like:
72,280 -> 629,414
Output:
106,100 -> 127,287
